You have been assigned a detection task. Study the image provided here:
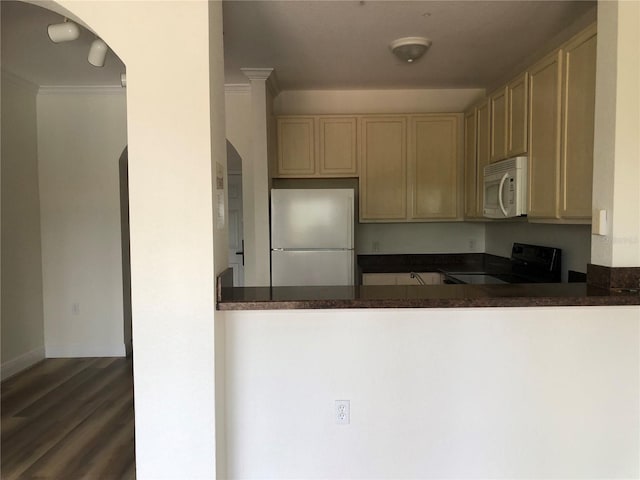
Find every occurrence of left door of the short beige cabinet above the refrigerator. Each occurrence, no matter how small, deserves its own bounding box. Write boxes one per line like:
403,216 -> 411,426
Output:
277,117 -> 316,177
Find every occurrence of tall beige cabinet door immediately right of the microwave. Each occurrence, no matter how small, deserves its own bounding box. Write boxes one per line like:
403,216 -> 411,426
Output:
529,50 -> 562,218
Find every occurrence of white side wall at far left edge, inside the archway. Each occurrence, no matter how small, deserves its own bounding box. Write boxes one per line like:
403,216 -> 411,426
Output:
1,71 -> 44,379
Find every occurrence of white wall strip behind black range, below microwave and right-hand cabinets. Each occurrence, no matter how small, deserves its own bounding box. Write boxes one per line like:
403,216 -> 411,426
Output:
485,222 -> 591,282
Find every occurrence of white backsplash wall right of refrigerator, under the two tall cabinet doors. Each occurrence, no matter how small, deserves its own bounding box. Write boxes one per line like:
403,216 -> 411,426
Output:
356,222 -> 488,256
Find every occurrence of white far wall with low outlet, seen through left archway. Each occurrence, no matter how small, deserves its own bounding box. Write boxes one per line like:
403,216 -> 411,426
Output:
37,91 -> 127,357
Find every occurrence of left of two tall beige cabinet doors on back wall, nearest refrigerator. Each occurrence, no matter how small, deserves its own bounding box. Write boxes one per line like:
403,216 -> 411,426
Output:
360,116 -> 407,221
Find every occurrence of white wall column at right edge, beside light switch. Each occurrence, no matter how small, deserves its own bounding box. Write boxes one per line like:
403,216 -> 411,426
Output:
591,1 -> 640,267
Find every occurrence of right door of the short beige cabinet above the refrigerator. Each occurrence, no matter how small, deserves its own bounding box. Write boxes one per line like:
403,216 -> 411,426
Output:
318,117 -> 358,177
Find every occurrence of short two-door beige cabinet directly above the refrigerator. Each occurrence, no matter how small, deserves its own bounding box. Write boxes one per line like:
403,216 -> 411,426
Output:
275,116 -> 358,178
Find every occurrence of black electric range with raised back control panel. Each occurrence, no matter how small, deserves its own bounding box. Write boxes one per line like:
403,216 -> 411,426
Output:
443,243 -> 562,285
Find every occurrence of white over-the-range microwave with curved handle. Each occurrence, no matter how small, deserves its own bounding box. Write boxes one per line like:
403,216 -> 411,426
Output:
483,157 -> 527,218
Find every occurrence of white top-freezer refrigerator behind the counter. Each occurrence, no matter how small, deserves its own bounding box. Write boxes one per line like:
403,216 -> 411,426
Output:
271,189 -> 355,287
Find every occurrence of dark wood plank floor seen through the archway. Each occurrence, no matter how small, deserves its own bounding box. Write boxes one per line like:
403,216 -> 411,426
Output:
0,358 -> 135,480
